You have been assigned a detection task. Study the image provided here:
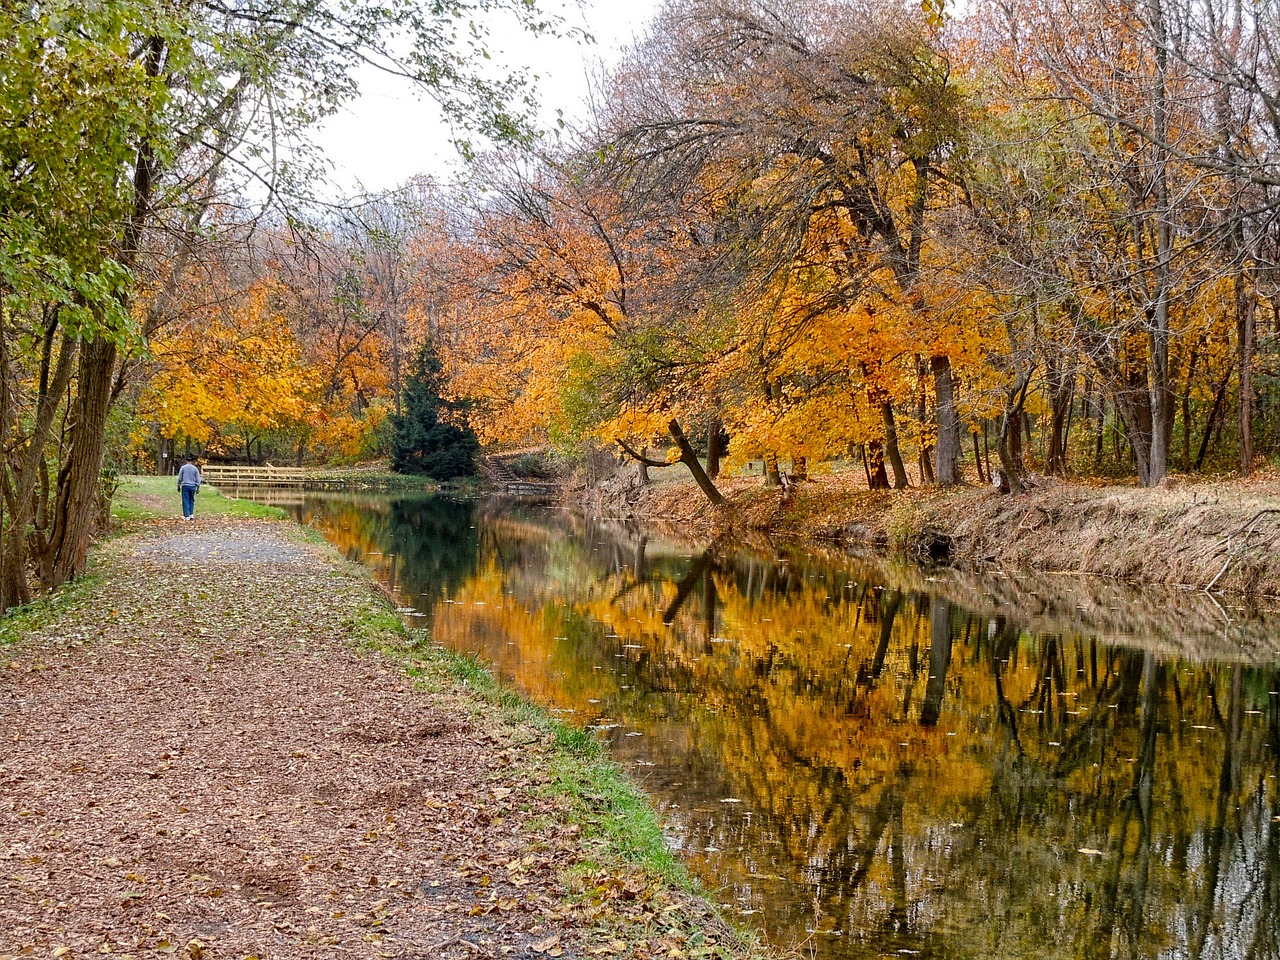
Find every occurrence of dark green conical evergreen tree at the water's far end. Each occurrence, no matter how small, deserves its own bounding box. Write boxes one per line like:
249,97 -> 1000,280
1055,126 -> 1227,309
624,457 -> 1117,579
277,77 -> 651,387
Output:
392,340 -> 480,480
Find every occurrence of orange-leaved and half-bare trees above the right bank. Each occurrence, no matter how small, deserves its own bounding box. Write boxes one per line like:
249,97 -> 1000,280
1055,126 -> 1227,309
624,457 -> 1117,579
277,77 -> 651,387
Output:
432,0 -> 1271,488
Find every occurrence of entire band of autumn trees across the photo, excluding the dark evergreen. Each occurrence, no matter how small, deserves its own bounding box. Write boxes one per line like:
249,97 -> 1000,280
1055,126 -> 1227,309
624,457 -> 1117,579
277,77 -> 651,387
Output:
10,0 -> 1280,604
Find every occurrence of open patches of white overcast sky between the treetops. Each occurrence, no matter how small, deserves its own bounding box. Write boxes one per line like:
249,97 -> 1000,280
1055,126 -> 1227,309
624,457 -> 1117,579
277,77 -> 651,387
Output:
316,0 -> 660,192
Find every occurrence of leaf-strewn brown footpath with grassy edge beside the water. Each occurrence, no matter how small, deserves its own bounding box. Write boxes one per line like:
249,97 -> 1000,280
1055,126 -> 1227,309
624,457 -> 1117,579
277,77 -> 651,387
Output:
0,506 -> 764,960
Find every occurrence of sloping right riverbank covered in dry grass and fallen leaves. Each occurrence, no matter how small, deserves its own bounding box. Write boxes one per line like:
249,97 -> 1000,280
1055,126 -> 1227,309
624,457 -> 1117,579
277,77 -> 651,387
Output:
591,471 -> 1280,596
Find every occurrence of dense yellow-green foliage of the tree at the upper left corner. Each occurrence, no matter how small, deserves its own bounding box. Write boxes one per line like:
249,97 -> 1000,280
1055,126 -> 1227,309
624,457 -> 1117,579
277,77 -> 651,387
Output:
0,3 -> 165,338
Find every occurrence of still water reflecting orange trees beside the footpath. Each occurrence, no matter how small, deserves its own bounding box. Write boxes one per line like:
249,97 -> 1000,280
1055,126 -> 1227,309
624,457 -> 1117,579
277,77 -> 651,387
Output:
282,497 -> 1280,960
